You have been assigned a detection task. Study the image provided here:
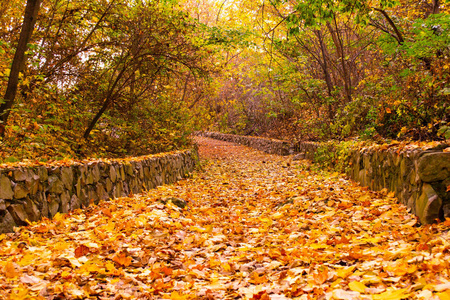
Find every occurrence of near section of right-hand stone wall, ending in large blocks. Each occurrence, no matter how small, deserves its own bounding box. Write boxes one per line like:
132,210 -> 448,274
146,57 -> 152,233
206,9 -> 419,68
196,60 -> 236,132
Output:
347,149 -> 450,224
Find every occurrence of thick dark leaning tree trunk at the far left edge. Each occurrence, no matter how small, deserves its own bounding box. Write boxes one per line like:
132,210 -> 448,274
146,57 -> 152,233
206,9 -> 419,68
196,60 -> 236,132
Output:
0,0 -> 41,126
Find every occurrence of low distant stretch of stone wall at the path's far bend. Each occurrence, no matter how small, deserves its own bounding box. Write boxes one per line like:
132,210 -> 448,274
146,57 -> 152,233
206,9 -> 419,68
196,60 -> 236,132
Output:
196,132 -> 293,155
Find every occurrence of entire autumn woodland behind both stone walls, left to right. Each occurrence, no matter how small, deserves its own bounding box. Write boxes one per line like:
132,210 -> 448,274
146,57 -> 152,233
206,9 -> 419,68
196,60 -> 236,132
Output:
0,0 -> 450,162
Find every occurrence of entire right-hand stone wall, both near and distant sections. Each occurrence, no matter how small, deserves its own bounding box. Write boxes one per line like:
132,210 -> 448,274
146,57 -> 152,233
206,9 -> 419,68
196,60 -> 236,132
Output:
201,132 -> 450,224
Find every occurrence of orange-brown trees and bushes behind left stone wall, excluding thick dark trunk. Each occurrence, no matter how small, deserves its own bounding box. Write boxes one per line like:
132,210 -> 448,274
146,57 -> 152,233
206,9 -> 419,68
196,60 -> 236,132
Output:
0,0 -> 220,161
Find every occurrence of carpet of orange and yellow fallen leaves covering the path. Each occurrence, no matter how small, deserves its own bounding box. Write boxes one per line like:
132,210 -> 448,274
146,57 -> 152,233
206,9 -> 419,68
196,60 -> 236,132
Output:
0,138 -> 450,300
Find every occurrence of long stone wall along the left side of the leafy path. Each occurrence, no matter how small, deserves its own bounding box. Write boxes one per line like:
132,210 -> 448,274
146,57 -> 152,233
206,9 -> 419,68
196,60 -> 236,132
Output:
0,150 -> 198,233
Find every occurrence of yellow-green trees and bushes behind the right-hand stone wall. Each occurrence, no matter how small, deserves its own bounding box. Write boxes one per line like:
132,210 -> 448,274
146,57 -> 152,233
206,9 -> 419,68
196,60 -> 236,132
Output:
207,0 -> 450,141
